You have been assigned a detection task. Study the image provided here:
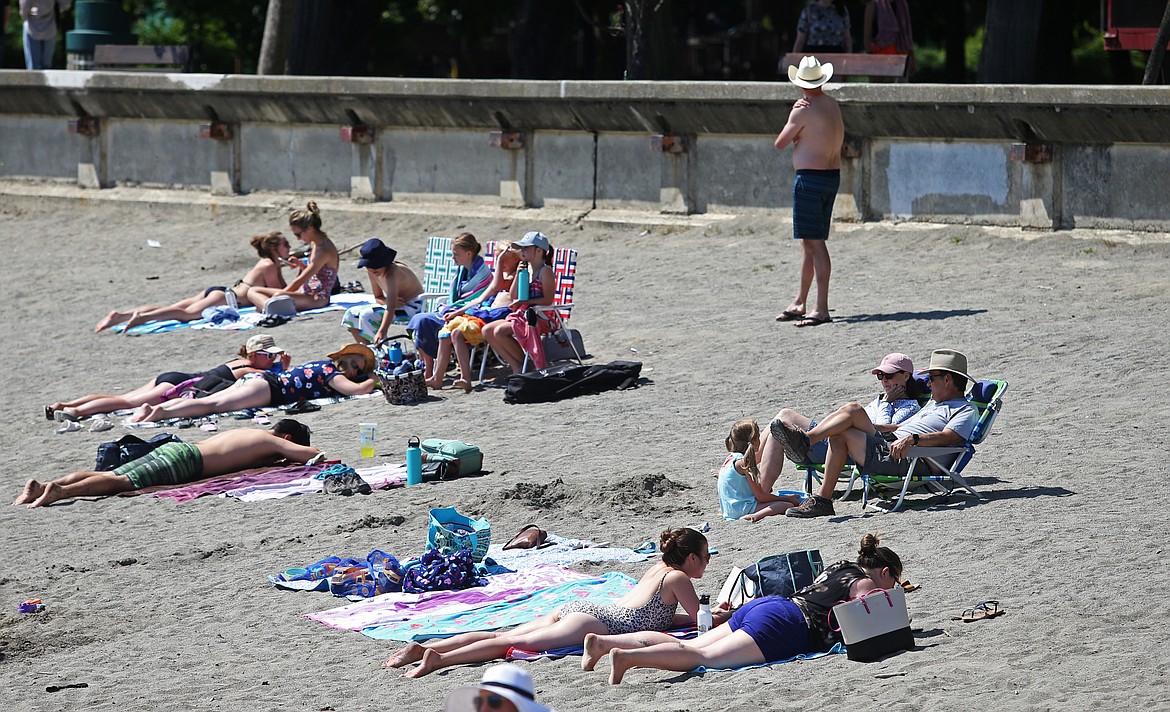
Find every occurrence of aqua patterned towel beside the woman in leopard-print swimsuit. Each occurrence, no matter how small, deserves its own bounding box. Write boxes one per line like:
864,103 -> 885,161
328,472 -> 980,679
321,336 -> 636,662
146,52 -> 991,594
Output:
362,573 -> 638,642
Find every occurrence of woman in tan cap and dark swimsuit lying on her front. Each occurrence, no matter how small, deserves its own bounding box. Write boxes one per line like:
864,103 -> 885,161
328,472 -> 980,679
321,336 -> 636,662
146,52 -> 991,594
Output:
44,333 -> 290,420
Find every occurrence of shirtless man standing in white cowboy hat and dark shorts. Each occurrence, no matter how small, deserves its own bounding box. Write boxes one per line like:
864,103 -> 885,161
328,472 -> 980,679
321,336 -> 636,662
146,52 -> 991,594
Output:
776,56 -> 845,326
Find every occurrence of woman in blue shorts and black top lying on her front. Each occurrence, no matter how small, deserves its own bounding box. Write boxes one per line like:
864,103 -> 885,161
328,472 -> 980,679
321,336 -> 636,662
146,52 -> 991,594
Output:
581,534 -> 902,685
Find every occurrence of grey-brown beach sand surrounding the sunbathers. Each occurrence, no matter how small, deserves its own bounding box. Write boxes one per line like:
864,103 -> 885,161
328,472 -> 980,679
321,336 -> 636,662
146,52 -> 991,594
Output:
0,186 -> 1170,712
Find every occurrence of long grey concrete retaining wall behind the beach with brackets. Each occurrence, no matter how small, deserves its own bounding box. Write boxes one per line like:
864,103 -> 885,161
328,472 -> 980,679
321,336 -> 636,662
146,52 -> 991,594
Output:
0,71 -> 1170,230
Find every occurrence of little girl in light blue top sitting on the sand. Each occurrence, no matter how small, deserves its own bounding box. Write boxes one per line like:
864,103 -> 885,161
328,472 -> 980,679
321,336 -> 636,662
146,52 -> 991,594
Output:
718,419 -> 800,521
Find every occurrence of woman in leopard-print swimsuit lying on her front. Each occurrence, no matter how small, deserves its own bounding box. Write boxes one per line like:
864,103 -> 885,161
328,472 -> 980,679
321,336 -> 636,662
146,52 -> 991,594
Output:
383,528 -> 711,677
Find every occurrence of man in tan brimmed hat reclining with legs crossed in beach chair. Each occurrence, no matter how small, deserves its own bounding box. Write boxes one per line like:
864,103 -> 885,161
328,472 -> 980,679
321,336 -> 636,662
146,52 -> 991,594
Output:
771,348 -> 979,517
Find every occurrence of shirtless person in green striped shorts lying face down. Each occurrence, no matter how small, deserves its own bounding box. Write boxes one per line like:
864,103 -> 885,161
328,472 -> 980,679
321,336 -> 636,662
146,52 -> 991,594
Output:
13,419 -> 321,509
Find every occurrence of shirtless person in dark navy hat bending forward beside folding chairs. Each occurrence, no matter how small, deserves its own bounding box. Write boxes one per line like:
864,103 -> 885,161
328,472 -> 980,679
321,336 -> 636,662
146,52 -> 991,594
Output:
342,237 -> 422,344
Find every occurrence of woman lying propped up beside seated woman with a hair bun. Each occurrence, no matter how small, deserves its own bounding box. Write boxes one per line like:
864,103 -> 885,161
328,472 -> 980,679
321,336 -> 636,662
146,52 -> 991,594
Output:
94,233 -> 289,332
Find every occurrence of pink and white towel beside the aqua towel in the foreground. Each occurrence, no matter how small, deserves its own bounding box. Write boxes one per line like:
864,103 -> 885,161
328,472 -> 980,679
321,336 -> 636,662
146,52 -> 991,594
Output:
305,566 -> 599,630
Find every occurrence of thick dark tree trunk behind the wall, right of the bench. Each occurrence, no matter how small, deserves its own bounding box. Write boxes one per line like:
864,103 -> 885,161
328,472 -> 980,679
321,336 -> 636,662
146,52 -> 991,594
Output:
979,0 -> 1043,84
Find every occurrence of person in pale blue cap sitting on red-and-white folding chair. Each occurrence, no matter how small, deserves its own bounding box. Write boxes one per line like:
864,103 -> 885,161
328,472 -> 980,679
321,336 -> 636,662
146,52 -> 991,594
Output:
483,233 -> 557,373
